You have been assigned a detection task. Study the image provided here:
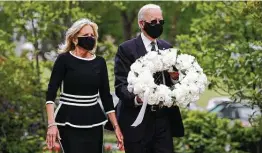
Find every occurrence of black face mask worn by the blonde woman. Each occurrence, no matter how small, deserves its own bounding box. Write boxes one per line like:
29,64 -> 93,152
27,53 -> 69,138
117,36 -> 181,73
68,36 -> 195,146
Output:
77,36 -> 96,51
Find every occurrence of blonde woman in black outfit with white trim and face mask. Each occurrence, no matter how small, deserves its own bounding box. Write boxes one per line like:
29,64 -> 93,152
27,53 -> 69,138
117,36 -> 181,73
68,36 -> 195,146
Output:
46,19 -> 123,153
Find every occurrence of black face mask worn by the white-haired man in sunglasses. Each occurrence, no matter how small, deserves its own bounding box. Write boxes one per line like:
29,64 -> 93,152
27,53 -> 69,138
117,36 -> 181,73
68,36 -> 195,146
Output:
144,22 -> 163,39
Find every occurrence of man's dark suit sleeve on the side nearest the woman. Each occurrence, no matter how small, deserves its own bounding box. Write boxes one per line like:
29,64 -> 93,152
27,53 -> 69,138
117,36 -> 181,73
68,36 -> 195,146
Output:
114,46 -> 135,107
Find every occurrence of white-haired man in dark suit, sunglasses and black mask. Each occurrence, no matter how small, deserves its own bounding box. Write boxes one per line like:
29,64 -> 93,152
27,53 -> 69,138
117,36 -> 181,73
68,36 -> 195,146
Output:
114,4 -> 184,153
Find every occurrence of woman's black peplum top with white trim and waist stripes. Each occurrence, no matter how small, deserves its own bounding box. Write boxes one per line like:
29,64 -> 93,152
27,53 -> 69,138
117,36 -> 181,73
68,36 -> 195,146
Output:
46,52 -> 114,128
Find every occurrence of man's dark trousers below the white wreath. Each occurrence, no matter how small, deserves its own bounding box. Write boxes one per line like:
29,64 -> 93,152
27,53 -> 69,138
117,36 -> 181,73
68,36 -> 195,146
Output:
124,111 -> 174,153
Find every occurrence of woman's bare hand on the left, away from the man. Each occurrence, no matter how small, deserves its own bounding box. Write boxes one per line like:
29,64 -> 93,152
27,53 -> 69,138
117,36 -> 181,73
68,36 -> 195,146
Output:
46,126 -> 61,150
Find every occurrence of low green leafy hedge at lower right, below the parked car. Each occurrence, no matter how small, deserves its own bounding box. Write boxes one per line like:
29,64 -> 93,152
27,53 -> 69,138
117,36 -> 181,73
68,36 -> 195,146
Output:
174,111 -> 262,153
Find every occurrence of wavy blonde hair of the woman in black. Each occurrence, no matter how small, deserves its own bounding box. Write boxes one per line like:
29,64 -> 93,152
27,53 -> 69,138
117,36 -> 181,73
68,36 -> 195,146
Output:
59,18 -> 98,54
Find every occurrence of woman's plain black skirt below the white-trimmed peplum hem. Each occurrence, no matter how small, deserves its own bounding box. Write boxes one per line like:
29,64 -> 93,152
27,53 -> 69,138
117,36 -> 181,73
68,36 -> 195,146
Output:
58,126 -> 103,153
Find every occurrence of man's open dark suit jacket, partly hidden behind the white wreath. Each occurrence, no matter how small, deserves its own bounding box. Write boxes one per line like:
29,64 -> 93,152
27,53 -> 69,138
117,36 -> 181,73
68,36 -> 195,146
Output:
114,35 -> 184,141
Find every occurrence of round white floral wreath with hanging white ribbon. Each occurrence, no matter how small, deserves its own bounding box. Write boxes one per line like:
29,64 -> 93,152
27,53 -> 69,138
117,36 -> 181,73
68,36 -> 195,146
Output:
127,48 -> 207,126
